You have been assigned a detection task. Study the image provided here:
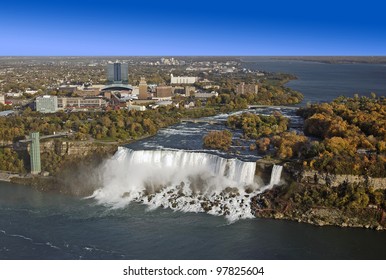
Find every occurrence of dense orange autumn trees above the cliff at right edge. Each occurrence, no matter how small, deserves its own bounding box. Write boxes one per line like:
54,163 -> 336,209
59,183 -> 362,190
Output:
299,95 -> 386,177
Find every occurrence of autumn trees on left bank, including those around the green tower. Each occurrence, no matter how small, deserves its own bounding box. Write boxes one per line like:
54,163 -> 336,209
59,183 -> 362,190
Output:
0,106 -> 216,174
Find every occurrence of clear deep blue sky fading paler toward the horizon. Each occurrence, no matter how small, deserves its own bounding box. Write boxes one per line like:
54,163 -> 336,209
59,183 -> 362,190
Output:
0,0 -> 386,56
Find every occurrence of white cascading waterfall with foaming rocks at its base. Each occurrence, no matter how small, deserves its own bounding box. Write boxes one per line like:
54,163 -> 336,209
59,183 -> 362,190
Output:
92,147 -> 281,221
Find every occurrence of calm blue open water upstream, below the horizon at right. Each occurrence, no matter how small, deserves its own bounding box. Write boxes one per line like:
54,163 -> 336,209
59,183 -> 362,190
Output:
243,58 -> 386,104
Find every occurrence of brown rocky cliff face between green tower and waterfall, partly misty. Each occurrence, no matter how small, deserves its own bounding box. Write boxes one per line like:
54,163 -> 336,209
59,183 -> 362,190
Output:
13,139 -> 117,196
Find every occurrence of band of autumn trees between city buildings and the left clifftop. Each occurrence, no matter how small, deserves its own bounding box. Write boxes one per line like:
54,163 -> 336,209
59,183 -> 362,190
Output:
0,106 -> 215,142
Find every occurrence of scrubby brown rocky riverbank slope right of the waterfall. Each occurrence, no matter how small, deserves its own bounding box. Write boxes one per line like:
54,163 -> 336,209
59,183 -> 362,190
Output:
251,168 -> 386,230
